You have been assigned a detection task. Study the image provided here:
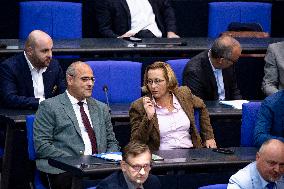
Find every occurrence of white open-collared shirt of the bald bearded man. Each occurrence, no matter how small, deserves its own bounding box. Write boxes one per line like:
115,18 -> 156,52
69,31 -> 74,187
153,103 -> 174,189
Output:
24,51 -> 47,103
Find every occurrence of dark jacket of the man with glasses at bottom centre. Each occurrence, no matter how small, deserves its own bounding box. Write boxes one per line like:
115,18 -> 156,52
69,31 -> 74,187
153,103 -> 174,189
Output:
96,171 -> 161,189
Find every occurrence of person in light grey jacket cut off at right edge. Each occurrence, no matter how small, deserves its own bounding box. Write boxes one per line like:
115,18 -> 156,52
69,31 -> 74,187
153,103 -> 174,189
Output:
262,41 -> 284,96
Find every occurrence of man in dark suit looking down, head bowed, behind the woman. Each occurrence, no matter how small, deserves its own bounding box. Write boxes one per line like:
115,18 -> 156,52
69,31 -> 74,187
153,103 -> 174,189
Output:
183,36 -> 242,100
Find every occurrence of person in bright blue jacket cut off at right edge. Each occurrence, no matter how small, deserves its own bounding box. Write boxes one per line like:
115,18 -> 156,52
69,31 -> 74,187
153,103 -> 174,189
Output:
253,90 -> 284,147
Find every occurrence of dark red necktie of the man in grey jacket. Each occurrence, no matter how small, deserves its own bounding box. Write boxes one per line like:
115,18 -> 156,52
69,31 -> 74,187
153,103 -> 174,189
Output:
78,102 -> 97,154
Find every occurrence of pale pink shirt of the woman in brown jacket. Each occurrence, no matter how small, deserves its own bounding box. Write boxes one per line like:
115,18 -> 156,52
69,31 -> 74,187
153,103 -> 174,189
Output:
155,94 -> 193,150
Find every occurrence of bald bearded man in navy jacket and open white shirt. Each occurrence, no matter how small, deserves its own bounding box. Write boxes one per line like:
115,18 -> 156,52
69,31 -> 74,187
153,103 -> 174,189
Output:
0,30 -> 66,109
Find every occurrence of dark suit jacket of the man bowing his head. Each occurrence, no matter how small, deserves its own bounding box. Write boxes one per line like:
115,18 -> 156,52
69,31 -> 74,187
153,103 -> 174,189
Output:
182,50 -> 241,100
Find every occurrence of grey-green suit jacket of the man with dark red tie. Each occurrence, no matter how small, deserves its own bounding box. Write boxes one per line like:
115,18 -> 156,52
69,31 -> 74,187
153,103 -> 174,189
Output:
33,92 -> 120,174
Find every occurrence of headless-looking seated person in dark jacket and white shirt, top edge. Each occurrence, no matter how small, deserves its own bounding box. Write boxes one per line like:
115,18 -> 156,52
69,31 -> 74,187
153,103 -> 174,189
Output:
96,0 -> 179,38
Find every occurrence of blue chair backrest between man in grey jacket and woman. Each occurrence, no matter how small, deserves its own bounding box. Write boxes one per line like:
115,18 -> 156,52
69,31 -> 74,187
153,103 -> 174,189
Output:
86,60 -> 142,104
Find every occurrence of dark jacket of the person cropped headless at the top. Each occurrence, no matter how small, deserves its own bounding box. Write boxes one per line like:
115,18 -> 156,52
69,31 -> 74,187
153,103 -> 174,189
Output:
96,0 -> 176,38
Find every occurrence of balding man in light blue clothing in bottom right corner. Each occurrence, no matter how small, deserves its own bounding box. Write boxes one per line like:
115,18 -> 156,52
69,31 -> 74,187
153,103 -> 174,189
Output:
227,139 -> 284,189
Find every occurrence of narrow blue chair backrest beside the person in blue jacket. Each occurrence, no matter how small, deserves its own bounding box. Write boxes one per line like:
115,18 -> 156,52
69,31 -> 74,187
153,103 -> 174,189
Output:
241,102 -> 261,147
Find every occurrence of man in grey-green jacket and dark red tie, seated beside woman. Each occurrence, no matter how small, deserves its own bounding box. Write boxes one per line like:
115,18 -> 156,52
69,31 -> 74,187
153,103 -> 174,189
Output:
34,62 -> 120,189
